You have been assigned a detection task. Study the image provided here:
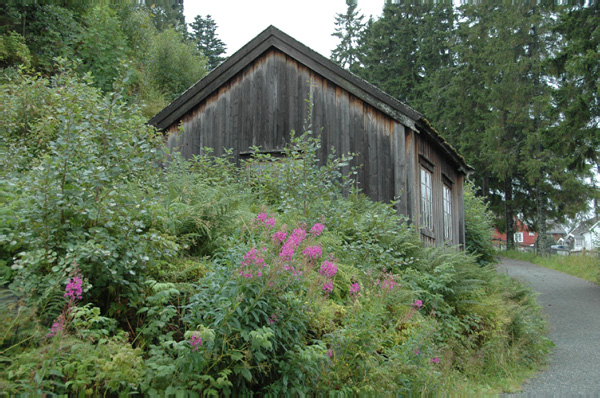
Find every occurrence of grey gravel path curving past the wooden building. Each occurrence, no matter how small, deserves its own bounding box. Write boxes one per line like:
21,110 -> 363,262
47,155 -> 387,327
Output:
498,258 -> 600,397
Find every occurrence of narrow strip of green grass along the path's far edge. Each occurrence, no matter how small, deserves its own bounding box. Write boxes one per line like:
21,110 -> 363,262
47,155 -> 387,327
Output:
502,250 -> 600,283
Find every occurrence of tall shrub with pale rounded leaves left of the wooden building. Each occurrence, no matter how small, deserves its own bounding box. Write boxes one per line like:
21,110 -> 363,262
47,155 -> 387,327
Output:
1,66 -> 177,320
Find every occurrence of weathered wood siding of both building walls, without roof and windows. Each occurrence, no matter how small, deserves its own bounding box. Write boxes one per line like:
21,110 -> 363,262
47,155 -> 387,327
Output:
167,48 -> 464,244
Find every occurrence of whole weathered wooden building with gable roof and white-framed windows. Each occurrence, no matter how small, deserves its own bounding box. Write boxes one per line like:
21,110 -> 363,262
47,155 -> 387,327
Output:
150,26 -> 471,245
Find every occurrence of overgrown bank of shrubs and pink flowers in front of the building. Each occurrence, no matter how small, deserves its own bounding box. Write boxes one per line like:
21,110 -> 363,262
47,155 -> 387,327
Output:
0,68 -> 550,395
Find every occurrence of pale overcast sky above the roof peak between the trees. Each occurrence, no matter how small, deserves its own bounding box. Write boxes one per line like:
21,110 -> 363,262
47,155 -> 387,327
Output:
183,0 -> 385,58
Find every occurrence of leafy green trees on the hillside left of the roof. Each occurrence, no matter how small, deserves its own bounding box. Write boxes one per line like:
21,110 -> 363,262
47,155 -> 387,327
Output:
0,2 -> 208,118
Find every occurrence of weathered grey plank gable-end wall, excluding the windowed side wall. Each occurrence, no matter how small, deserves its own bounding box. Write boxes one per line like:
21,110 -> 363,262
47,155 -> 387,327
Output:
168,49 -> 403,202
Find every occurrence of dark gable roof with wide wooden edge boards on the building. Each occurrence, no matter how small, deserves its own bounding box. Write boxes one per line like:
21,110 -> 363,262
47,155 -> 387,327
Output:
148,26 -> 473,174
